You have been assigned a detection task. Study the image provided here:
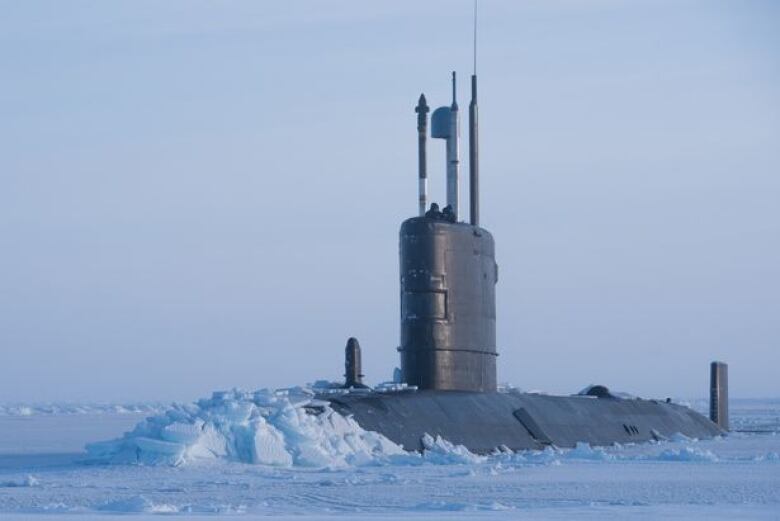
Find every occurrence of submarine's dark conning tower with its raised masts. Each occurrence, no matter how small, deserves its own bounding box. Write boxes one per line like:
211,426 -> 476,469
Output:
398,71 -> 498,392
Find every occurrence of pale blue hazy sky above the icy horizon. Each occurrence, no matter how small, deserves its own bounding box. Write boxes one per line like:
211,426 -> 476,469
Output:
0,0 -> 780,401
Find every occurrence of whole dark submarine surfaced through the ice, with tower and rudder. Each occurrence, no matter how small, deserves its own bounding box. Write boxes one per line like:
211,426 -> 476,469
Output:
309,67 -> 728,454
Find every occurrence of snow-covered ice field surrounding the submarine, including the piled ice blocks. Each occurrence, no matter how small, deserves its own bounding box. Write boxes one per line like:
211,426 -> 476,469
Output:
0,393 -> 780,520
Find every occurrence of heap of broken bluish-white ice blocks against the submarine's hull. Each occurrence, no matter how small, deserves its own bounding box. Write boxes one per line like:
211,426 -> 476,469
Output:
86,388 -> 406,467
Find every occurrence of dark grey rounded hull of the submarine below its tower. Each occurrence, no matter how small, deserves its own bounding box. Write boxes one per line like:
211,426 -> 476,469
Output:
320,391 -> 724,453
